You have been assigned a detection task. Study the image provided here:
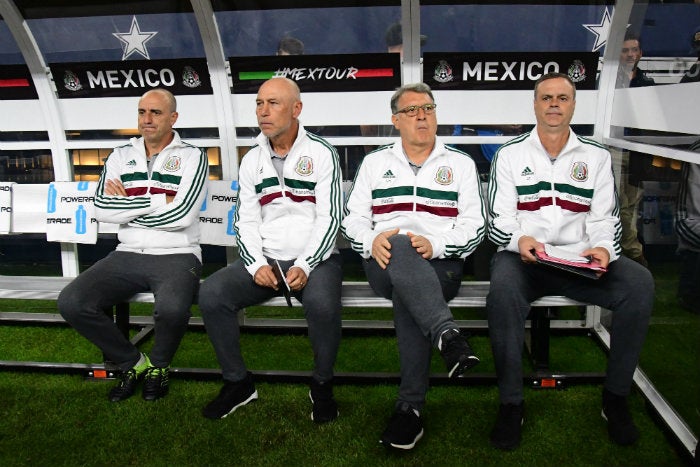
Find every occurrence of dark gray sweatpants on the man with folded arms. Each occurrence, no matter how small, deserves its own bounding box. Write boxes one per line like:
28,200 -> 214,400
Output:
57,251 -> 202,371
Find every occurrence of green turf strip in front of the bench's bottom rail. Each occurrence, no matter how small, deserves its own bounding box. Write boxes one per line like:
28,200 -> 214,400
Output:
0,372 -> 683,467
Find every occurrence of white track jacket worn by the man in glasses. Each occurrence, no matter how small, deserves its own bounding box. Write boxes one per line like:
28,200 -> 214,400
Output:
341,140 -> 486,259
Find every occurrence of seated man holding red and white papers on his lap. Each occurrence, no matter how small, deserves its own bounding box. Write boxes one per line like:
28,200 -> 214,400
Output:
486,73 -> 654,450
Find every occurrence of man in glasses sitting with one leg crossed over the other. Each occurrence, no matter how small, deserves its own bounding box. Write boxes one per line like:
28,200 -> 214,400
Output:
341,83 -> 485,449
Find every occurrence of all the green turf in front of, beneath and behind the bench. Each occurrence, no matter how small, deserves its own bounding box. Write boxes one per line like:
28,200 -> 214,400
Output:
0,258 -> 700,467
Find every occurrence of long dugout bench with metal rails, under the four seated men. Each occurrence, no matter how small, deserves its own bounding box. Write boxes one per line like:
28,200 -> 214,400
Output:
0,276 -> 604,388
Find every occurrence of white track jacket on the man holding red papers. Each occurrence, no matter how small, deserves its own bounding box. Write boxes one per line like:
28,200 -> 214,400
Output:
487,128 -> 621,261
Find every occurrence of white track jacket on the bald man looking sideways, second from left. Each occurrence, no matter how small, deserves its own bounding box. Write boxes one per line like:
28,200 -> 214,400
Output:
233,125 -> 343,276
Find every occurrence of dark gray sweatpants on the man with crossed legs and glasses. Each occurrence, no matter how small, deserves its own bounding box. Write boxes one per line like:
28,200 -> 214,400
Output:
363,235 -> 464,411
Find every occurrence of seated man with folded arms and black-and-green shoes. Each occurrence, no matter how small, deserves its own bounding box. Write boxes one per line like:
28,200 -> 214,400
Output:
58,89 -> 208,402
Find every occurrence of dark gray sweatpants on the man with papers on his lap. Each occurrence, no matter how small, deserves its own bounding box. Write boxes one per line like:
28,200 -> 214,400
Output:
486,251 -> 654,404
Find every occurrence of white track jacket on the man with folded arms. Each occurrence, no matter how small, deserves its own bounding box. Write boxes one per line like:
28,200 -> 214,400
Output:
95,132 -> 209,260
